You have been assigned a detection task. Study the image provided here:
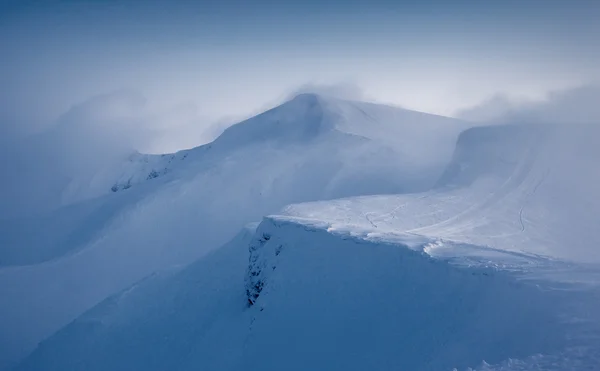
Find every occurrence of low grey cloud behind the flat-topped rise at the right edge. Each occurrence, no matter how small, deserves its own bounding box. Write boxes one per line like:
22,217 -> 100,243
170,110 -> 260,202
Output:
458,85 -> 600,124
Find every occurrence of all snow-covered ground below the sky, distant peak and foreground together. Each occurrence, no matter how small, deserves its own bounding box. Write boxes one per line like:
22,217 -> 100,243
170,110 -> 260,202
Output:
0,94 -> 600,371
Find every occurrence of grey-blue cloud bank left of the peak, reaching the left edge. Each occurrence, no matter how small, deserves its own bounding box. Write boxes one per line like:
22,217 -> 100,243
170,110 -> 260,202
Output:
0,90 -> 230,217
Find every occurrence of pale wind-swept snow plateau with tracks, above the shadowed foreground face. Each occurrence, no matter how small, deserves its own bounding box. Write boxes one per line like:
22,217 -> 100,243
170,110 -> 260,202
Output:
285,125 -> 600,263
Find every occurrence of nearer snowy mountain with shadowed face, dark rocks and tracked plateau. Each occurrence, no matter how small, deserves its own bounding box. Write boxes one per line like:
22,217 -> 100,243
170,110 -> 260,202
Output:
12,120 -> 600,370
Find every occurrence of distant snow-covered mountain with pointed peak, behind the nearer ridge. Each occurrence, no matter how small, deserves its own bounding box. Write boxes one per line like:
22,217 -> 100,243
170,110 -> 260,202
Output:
0,94 -> 468,370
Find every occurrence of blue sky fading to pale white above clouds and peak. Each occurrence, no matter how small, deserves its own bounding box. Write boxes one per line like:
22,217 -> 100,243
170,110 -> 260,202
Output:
0,0 -> 600,131
